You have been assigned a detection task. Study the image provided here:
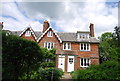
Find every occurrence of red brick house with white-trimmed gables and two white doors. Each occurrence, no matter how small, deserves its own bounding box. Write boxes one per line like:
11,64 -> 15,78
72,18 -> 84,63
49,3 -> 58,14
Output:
12,21 -> 99,72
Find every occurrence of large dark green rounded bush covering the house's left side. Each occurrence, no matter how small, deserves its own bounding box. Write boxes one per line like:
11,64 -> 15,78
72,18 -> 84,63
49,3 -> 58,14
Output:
2,32 -> 44,81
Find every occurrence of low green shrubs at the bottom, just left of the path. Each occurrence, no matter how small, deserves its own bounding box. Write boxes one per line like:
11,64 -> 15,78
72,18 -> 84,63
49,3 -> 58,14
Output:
29,68 -> 63,81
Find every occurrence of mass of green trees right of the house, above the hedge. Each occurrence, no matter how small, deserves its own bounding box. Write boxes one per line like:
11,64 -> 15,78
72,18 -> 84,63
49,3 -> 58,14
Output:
99,27 -> 120,63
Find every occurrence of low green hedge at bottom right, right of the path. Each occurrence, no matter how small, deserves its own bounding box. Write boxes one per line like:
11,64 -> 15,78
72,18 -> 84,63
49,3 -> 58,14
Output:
72,61 -> 120,81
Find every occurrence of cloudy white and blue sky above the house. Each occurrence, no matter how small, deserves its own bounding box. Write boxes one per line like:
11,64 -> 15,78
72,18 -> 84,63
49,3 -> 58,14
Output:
0,0 -> 119,37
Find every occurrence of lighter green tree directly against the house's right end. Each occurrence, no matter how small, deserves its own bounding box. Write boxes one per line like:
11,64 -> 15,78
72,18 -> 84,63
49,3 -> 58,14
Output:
99,32 -> 113,63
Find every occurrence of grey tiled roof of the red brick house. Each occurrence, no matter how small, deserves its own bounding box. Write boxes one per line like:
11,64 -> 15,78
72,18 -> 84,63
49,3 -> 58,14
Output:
11,31 -> 99,43
